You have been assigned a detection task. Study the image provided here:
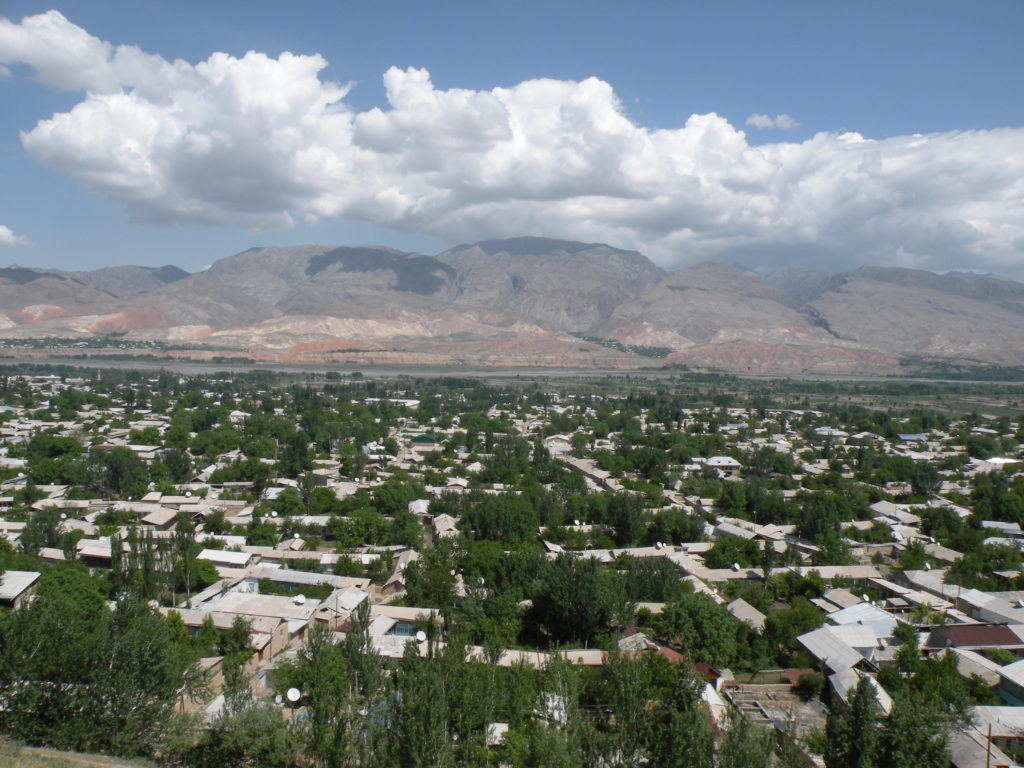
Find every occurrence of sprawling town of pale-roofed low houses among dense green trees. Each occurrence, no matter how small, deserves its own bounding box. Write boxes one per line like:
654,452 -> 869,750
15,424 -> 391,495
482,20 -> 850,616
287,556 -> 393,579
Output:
0,366 -> 1024,768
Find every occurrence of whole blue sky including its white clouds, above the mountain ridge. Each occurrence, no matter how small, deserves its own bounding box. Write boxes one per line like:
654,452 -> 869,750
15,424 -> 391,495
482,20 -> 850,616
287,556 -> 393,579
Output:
0,0 -> 1024,280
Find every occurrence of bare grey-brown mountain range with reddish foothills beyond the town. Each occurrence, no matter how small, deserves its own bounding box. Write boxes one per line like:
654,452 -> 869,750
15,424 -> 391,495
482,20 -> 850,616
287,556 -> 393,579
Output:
0,238 -> 1024,375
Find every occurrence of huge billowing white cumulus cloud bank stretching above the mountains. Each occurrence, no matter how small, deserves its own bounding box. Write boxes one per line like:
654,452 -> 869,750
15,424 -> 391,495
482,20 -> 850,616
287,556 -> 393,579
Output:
0,11 -> 1024,271
